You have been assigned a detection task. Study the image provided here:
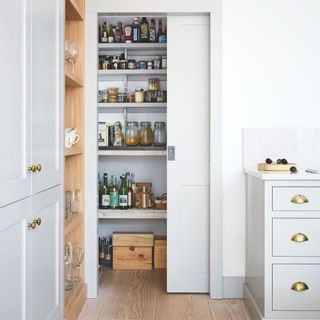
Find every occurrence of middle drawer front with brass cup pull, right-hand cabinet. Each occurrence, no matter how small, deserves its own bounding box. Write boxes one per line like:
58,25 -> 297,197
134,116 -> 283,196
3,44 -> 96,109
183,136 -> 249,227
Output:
272,219 -> 320,257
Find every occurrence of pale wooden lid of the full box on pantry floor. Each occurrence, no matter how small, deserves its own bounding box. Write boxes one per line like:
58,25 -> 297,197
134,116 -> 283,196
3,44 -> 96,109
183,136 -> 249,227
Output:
112,232 -> 154,247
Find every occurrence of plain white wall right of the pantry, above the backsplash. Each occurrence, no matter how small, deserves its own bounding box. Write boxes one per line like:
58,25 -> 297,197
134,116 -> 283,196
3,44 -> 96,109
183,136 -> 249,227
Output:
222,0 -> 320,276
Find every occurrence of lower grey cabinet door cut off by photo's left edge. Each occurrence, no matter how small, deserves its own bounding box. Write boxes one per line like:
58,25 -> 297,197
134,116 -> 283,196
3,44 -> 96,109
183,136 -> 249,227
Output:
0,198 -> 31,320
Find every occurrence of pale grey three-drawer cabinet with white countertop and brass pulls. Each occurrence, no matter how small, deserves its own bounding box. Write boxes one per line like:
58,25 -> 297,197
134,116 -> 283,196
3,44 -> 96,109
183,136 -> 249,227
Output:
244,170 -> 320,320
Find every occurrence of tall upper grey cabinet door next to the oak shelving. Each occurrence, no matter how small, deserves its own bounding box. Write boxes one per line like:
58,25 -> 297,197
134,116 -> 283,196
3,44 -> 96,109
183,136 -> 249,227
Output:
31,0 -> 64,194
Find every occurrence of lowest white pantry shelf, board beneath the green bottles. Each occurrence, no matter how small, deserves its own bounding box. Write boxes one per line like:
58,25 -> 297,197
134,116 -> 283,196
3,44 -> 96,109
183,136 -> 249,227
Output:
98,209 -> 167,219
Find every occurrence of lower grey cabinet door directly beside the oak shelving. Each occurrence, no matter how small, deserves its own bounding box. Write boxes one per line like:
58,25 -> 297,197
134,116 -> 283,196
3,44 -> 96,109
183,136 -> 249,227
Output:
30,186 -> 63,320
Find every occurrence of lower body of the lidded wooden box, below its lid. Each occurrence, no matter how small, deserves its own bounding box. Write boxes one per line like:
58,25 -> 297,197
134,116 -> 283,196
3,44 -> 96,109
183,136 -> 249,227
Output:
112,246 -> 152,270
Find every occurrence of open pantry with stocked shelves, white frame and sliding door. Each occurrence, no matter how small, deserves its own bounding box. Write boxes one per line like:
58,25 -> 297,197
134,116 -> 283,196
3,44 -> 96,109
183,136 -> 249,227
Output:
85,13 -> 210,298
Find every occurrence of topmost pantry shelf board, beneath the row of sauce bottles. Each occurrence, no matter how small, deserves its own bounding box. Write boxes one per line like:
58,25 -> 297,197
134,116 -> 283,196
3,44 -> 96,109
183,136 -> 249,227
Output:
98,43 -> 167,51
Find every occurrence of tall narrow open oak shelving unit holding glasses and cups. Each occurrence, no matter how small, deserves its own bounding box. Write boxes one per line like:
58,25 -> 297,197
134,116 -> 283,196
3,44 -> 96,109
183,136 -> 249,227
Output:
64,0 -> 87,320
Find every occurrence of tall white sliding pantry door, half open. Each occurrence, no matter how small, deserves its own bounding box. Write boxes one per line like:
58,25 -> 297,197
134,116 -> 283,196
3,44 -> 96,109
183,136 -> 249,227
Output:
167,16 -> 210,292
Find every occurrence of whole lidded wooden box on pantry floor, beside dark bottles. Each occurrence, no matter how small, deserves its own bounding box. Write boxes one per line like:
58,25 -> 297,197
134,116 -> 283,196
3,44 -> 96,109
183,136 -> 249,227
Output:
112,232 -> 154,270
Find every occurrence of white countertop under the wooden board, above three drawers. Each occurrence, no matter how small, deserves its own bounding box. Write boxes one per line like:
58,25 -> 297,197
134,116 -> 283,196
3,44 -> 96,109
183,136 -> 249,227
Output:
244,168 -> 320,180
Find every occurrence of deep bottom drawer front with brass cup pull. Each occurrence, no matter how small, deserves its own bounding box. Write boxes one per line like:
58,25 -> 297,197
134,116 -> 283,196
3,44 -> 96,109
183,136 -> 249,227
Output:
273,264 -> 320,311
